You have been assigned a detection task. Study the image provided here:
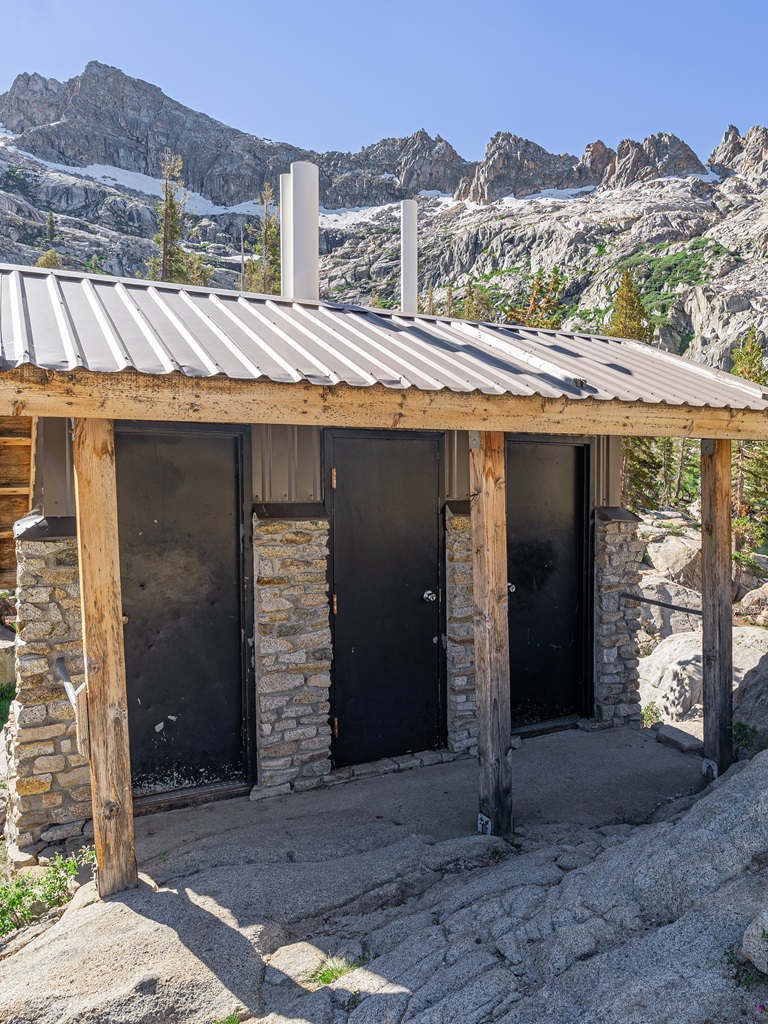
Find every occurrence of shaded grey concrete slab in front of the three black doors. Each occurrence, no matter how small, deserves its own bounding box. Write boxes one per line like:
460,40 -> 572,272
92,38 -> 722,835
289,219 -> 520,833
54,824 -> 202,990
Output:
135,729 -> 705,887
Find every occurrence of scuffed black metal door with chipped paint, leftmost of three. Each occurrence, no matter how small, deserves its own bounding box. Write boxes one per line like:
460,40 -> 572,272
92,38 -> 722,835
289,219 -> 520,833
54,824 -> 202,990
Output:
116,426 -> 250,794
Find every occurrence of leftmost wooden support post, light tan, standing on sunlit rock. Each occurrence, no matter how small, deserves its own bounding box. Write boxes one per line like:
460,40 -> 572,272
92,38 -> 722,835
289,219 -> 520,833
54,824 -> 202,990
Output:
74,420 -> 138,897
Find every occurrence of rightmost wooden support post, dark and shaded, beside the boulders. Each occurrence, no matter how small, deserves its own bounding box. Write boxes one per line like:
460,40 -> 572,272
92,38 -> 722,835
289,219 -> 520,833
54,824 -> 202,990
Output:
701,440 -> 733,775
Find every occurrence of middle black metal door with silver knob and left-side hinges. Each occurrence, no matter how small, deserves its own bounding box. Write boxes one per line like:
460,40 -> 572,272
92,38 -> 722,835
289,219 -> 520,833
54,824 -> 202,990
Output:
327,432 -> 442,765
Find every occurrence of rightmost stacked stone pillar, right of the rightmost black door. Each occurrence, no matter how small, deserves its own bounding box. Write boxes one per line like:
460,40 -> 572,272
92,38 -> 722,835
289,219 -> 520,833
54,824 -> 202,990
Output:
595,508 -> 643,728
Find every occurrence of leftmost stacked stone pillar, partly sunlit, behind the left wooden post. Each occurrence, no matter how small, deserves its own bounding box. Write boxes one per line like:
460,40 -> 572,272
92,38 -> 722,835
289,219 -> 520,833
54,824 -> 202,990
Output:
6,540 -> 91,865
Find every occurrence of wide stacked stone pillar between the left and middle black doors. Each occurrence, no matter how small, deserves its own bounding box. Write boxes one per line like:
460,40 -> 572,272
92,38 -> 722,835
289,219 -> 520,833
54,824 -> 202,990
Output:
252,518 -> 331,799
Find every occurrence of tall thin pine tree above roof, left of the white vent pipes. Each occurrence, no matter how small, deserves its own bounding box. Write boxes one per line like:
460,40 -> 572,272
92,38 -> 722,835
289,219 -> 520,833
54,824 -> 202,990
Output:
150,150 -> 213,285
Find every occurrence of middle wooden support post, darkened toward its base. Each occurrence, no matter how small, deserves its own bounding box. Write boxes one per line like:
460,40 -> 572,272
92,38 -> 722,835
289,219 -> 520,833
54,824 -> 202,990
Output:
469,431 -> 512,836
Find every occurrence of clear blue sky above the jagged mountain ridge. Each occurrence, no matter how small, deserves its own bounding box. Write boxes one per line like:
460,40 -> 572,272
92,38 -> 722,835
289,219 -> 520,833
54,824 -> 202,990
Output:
0,0 -> 768,160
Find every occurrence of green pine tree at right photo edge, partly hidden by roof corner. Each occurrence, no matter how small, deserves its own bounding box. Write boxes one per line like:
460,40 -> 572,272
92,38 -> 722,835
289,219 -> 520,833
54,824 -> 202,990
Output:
731,326 -> 768,551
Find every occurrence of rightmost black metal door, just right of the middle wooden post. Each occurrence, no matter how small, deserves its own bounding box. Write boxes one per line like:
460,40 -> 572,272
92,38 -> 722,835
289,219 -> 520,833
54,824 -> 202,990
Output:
506,438 -> 591,725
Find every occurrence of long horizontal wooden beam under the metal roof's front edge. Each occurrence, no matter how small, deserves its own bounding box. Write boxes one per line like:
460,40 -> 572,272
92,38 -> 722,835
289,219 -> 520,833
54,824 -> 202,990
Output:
0,367 -> 768,440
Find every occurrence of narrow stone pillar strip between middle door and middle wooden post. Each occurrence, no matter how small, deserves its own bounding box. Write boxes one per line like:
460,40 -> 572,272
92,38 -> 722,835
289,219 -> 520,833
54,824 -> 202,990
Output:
445,510 -> 477,754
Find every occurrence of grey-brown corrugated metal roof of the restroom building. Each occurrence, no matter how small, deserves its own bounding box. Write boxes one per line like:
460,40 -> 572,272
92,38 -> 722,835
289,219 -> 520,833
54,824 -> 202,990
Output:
0,265 -> 768,410
